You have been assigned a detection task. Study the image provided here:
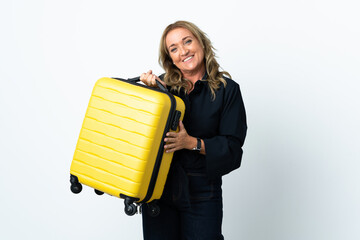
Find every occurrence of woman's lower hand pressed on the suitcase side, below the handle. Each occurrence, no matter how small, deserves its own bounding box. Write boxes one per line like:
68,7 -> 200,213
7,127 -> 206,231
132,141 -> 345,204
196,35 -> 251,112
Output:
164,121 -> 197,153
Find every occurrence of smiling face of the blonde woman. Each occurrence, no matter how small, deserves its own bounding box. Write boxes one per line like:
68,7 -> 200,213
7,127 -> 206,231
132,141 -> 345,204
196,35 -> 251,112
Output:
165,28 -> 205,75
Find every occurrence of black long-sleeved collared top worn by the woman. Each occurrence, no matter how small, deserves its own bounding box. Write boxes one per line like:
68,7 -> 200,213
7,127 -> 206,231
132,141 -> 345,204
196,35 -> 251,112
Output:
169,75 -> 247,179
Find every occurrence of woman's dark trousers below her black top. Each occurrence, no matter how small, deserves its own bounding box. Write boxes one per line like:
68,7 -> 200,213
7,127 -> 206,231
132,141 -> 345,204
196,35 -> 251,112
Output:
142,171 -> 224,240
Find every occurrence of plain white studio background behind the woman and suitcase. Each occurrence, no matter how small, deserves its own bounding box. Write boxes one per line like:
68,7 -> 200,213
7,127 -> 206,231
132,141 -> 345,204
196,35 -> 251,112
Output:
0,0 -> 360,240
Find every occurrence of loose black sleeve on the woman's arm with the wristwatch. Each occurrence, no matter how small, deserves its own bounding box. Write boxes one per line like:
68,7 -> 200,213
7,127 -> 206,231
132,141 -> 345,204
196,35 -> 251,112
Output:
203,84 -> 247,179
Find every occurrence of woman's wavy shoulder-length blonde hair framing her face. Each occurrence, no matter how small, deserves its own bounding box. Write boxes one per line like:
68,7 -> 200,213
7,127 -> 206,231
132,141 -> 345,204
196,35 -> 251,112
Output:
159,21 -> 231,100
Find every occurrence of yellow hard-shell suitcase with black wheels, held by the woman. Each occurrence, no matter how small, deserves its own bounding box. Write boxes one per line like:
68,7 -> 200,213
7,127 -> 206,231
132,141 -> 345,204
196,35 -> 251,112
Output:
70,78 -> 185,215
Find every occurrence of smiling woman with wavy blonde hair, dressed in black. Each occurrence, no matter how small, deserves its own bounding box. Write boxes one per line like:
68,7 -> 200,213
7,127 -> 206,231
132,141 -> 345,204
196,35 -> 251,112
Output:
140,21 -> 247,240
